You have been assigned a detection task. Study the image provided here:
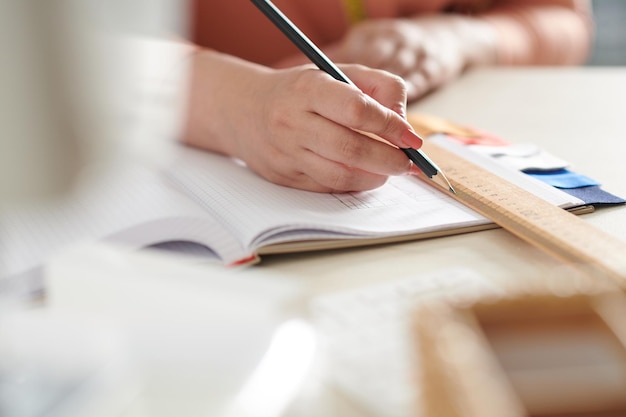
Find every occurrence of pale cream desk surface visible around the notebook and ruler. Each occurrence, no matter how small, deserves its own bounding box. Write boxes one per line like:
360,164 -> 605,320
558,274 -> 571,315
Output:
35,68 -> 626,417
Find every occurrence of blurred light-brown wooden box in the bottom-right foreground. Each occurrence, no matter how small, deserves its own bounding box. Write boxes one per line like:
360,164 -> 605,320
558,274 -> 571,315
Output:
416,276 -> 626,417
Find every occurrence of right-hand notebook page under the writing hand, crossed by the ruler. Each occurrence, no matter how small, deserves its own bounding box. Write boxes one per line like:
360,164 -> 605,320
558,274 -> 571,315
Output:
169,140 -> 582,255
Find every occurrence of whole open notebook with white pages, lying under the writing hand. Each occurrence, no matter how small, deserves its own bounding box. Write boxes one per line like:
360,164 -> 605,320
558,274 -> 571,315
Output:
0,137 -> 583,276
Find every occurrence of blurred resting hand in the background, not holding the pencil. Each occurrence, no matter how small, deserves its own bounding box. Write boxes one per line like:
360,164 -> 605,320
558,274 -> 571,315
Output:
325,15 -> 495,100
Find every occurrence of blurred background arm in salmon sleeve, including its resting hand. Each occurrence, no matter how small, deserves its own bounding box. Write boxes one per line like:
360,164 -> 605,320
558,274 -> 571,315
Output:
278,0 -> 592,100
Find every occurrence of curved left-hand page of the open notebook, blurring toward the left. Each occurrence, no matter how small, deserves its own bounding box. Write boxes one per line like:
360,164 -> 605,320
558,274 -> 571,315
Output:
0,165 -> 241,277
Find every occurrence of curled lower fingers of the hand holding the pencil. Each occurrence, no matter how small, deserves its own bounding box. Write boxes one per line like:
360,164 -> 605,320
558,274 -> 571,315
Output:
246,106 -> 411,192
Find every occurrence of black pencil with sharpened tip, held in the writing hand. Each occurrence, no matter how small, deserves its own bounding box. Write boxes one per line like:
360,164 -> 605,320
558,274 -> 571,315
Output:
251,0 -> 456,194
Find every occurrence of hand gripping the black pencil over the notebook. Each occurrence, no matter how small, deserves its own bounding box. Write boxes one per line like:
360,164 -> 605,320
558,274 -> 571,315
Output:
186,52 -> 421,192
